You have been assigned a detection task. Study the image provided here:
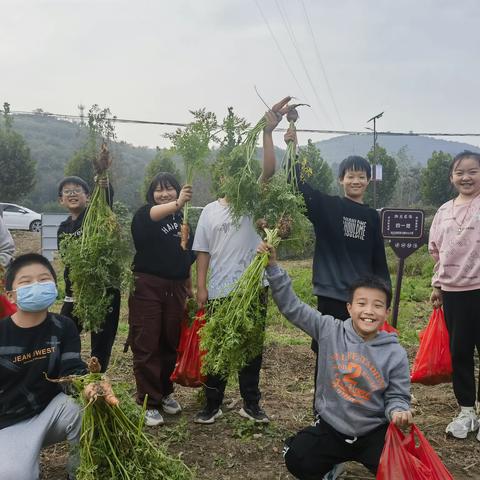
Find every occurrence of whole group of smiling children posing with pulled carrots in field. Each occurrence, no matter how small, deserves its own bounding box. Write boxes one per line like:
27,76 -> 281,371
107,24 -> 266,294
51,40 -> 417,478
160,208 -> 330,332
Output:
0,99 -> 480,480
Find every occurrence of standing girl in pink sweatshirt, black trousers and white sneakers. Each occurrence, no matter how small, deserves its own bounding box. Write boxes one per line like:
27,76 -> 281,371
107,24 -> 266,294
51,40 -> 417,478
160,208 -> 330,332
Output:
428,151 -> 480,441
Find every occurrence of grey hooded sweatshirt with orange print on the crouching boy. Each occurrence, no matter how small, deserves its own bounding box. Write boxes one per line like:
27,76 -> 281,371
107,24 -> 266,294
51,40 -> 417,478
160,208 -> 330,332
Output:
267,265 -> 410,437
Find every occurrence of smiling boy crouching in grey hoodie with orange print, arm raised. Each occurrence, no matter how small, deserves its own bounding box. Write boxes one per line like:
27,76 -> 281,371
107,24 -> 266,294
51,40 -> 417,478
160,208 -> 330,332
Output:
258,243 -> 412,480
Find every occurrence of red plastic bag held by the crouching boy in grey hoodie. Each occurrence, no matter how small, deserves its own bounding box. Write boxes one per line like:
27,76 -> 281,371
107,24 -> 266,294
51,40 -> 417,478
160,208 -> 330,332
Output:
376,423 -> 453,480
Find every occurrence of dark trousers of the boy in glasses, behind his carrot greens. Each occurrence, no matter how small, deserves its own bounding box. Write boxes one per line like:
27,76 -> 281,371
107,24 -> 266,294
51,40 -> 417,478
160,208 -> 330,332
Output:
60,289 -> 120,373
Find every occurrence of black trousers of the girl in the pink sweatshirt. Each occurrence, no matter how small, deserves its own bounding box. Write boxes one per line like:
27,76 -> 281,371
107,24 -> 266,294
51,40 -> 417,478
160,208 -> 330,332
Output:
442,290 -> 480,407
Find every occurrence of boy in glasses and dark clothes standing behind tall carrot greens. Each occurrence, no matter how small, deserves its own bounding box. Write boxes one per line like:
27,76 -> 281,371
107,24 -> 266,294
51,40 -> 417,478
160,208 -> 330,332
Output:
57,176 -> 120,372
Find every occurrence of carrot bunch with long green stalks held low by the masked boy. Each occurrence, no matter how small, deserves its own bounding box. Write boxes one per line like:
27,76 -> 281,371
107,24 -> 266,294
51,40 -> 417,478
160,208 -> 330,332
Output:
60,373 -> 194,480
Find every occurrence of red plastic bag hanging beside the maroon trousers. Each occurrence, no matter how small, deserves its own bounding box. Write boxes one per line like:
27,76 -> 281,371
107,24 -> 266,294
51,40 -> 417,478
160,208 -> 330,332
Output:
170,309 -> 206,388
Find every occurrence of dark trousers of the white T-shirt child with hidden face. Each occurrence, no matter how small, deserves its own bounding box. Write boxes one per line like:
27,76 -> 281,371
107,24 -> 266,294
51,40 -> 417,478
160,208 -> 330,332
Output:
205,288 -> 268,409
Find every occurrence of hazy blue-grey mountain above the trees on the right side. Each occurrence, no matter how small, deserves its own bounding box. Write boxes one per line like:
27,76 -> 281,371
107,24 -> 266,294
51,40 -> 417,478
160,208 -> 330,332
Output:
315,135 -> 480,166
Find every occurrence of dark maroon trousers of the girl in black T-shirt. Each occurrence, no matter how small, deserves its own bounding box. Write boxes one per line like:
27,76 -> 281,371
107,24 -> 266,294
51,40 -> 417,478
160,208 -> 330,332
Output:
128,273 -> 187,408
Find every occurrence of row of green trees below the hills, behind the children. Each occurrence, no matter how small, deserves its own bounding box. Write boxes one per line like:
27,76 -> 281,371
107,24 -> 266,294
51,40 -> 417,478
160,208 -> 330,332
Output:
0,103 -> 458,210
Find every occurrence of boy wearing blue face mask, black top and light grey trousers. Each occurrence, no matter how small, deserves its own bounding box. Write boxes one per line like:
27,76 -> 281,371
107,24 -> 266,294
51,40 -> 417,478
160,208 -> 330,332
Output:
0,253 -> 87,480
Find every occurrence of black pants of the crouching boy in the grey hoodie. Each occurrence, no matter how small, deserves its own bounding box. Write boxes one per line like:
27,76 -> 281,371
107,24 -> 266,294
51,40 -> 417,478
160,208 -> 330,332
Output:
284,420 -> 393,480
